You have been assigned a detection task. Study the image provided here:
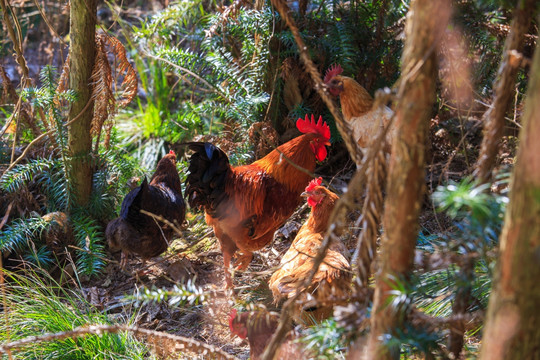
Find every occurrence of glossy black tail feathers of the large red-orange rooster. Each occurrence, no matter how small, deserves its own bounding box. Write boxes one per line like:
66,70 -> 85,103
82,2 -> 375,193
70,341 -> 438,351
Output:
185,142 -> 231,218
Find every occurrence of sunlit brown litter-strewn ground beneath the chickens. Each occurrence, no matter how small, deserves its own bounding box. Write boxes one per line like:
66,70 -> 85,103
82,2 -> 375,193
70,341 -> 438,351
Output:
82,207 -> 307,359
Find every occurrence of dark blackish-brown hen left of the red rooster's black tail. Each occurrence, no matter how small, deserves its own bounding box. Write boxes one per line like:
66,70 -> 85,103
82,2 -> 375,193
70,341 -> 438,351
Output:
105,150 -> 186,268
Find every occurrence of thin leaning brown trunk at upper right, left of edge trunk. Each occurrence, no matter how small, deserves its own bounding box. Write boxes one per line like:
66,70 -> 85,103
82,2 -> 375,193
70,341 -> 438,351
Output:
475,0 -> 536,183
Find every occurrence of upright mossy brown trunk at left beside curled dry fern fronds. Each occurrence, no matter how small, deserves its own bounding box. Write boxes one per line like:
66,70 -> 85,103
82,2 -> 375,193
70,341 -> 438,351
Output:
68,0 -> 97,206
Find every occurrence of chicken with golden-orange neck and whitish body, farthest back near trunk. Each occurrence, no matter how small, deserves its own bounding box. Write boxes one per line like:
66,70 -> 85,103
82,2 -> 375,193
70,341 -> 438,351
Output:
324,65 -> 397,153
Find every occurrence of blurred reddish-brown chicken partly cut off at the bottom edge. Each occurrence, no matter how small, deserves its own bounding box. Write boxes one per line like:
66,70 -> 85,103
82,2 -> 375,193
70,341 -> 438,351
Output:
229,309 -> 311,360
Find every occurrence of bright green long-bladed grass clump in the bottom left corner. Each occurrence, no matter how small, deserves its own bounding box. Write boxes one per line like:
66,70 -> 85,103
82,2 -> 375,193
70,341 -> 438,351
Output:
0,273 -> 153,360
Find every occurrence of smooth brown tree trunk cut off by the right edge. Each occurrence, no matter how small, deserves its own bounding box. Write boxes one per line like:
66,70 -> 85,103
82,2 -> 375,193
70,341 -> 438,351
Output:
480,27 -> 540,360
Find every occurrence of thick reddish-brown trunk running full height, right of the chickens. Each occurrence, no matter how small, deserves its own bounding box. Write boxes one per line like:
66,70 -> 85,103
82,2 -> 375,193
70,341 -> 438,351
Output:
367,0 -> 450,359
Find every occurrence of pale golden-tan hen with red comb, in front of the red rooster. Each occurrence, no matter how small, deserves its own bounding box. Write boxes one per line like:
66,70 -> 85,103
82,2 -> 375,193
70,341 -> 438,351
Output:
269,178 -> 351,323
